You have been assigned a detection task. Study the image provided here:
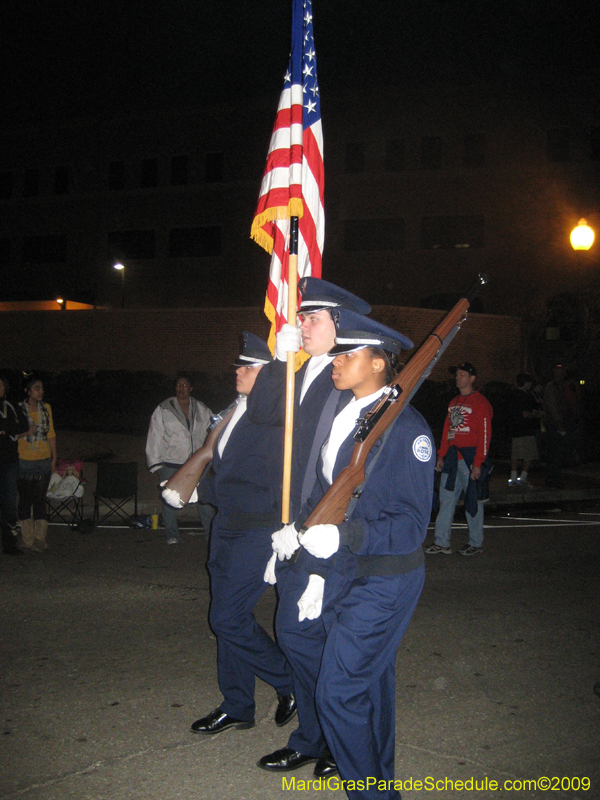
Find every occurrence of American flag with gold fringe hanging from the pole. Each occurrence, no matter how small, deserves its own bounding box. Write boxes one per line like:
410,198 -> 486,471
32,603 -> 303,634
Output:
250,0 -> 325,350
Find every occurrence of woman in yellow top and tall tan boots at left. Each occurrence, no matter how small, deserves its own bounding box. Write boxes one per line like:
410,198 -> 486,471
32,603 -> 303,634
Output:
17,375 -> 56,553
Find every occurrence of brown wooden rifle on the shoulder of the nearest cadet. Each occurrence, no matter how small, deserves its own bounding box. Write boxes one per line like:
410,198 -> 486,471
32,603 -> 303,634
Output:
292,274 -> 488,536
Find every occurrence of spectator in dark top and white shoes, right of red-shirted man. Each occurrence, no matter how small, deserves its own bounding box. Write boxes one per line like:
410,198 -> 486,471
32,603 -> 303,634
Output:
508,372 -> 541,489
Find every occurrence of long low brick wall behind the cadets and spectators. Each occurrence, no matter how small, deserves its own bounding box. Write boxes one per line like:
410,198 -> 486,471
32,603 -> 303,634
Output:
0,306 -> 521,384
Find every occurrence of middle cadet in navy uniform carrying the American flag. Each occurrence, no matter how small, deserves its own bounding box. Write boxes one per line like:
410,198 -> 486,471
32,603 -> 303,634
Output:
248,278 -> 371,777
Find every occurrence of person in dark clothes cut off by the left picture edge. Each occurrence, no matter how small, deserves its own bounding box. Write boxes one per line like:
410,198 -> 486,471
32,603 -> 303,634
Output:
0,376 -> 30,556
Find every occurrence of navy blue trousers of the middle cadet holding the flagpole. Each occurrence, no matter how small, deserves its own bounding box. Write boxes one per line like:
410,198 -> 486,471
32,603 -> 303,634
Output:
275,554 -> 326,757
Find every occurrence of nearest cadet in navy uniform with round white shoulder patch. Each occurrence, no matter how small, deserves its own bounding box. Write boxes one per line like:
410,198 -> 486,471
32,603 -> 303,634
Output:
270,309 -> 435,800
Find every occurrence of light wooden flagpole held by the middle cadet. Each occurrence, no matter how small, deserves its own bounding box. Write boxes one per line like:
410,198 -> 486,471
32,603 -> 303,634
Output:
281,217 -> 298,525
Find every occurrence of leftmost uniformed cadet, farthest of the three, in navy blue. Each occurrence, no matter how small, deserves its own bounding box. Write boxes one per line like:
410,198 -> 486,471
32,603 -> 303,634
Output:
192,332 -> 296,734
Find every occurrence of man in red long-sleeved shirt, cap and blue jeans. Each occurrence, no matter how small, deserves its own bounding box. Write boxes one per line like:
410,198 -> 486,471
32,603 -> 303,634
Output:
425,361 -> 493,556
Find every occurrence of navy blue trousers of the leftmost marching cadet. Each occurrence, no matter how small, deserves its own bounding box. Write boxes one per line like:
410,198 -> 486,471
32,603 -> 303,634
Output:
208,516 -> 294,721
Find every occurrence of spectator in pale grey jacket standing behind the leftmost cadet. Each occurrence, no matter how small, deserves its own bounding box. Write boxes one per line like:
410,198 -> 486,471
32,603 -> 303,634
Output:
146,374 -> 212,544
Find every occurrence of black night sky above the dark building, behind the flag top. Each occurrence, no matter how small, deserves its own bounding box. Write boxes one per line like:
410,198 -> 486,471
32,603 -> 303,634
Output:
0,0 -> 599,123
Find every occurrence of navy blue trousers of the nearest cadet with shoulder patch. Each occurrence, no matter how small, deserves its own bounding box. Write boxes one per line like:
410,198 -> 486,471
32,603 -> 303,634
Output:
316,567 -> 425,800
